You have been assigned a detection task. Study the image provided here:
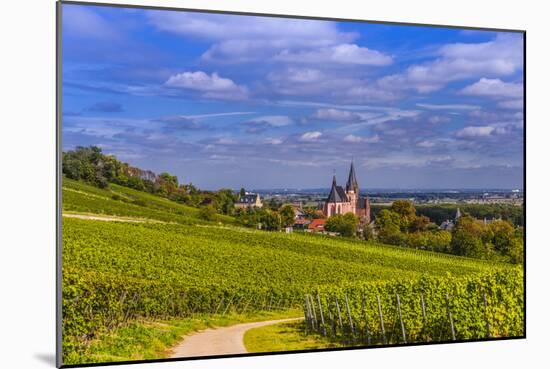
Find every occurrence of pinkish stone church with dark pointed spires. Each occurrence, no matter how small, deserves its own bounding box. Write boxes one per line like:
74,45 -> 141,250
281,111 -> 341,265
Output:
323,162 -> 370,224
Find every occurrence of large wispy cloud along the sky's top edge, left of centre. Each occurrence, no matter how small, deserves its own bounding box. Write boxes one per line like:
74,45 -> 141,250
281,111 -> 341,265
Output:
149,12 -> 358,63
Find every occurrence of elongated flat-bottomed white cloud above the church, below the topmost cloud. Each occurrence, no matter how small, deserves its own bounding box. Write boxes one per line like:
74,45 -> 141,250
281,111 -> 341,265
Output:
275,44 -> 393,66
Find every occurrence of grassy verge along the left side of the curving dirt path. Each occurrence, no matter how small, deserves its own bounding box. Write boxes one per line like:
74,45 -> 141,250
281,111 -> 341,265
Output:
68,310 -> 301,364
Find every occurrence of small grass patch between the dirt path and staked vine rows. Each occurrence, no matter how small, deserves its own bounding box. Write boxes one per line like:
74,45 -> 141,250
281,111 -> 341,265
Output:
244,321 -> 342,352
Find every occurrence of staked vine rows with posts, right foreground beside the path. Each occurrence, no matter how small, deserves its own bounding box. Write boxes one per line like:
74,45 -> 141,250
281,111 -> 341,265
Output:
304,269 -> 524,345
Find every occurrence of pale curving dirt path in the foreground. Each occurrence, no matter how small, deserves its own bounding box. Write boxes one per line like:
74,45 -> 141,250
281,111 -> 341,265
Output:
170,318 -> 303,358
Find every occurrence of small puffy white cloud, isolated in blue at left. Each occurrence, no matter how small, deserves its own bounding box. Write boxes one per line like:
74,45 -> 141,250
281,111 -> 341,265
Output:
165,71 -> 247,100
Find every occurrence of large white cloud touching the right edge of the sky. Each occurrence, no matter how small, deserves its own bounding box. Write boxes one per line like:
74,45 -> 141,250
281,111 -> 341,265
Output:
378,35 -> 523,93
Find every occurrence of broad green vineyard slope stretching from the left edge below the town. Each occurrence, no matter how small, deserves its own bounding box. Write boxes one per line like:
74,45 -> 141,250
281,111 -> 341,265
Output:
63,179 -> 522,363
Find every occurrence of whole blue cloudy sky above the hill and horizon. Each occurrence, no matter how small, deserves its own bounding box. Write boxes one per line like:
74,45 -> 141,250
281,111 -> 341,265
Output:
62,4 -> 524,190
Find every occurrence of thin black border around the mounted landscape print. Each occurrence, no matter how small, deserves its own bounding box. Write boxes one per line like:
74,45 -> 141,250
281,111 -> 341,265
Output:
55,0 -> 527,368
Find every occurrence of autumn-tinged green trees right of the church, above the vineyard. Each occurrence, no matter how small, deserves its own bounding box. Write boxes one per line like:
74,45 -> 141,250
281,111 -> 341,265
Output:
325,200 -> 524,263
